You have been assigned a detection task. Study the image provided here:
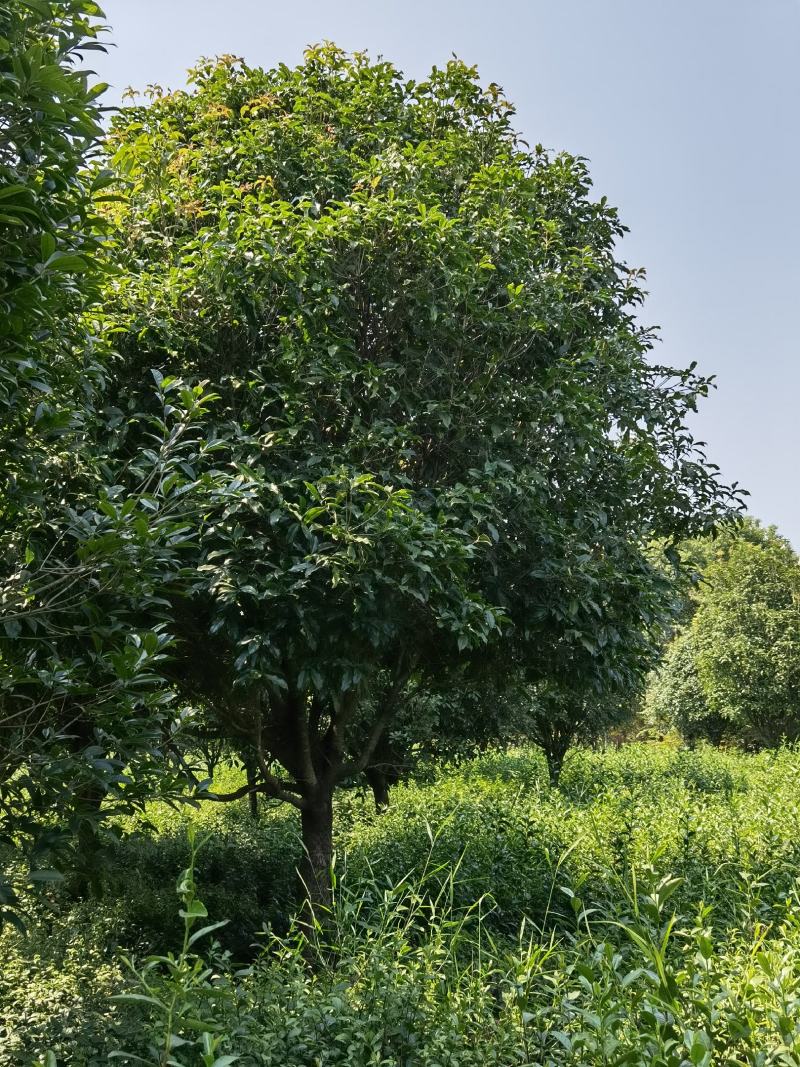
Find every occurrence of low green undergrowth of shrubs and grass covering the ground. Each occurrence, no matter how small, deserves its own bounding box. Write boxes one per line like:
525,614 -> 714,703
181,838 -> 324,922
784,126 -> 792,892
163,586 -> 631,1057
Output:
0,746 -> 800,1067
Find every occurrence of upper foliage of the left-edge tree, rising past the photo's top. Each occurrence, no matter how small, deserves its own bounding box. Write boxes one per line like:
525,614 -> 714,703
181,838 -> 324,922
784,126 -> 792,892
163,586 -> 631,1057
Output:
0,0 -> 109,526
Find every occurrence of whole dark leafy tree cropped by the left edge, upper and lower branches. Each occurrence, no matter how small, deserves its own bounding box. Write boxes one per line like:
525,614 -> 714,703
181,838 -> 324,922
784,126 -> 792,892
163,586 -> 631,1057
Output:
0,0 -> 234,921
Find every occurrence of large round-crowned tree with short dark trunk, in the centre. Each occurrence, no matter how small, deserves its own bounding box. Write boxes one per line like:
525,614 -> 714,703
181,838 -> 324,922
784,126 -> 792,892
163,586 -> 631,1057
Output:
98,46 -> 737,897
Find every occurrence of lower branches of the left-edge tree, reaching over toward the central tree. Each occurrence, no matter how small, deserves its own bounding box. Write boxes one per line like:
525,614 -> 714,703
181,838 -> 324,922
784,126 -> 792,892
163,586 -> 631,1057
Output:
0,371 -> 237,885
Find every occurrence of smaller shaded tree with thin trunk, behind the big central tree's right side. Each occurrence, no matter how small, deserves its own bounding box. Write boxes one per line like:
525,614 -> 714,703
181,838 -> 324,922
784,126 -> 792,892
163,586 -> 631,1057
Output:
379,554 -> 679,793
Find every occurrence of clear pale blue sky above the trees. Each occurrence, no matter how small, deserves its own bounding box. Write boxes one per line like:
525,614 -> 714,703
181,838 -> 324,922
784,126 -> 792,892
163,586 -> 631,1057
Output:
94,0 -> 800,548
